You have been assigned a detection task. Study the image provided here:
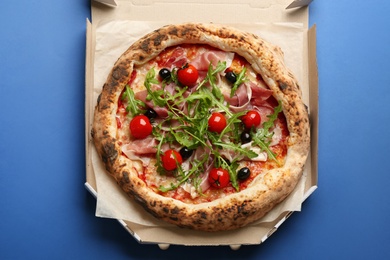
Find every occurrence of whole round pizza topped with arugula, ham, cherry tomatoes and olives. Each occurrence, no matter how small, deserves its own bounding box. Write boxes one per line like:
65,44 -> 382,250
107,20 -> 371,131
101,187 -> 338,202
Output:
91,23 -> 310,231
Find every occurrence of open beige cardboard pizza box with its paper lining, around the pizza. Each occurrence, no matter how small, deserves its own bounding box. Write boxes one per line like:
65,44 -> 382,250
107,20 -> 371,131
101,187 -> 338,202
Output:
85,0 -> 318,249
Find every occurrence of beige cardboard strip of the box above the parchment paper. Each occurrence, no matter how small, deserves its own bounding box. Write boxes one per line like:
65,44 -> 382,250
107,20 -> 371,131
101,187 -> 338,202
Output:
92,0 -> 310,28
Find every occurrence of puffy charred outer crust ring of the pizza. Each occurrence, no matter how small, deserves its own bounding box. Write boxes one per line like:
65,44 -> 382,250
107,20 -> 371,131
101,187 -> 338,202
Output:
91,23 -> 310,231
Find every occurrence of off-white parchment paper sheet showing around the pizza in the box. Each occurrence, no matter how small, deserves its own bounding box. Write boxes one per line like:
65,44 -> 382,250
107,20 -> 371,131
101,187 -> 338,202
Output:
91,20 -> 309,227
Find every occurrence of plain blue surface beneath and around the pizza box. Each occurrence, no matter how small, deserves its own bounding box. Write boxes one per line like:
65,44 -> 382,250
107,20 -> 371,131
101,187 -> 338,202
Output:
0,0 -> 390,259
